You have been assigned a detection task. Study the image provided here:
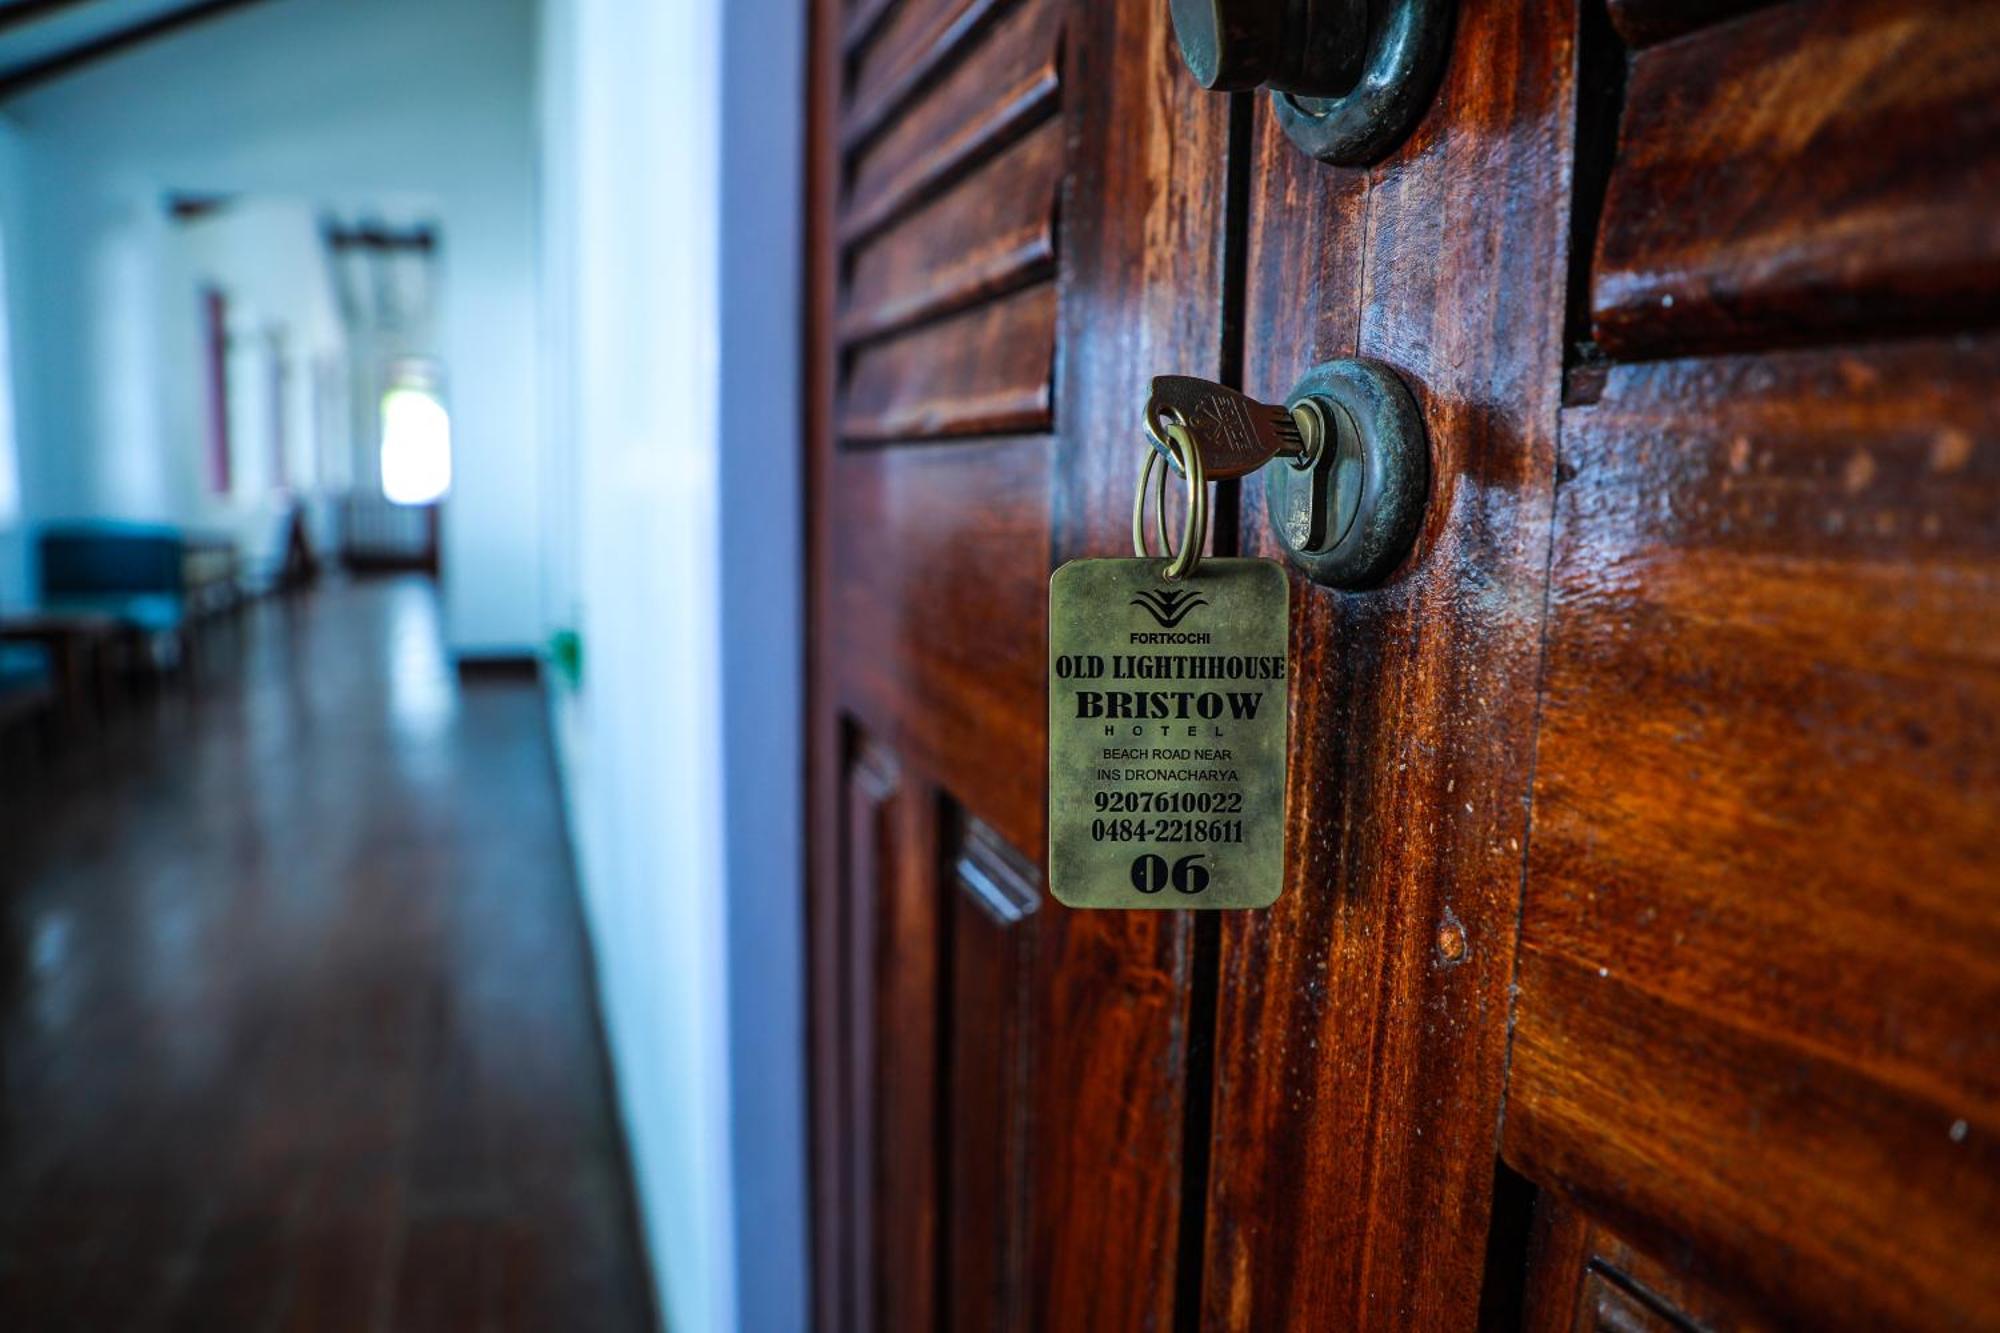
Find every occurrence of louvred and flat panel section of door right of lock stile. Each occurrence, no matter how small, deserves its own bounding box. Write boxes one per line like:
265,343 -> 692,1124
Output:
1502,0 -> 2000,1329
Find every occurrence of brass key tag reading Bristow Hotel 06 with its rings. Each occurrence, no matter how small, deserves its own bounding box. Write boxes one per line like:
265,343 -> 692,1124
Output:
1048,400 -> 1290,909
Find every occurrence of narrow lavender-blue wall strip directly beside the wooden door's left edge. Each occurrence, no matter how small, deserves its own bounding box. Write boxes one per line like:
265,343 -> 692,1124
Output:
716,0 -> 810,1331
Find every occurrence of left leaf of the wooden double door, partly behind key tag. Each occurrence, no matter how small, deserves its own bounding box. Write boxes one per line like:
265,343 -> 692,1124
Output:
810,0 -> 1228,1331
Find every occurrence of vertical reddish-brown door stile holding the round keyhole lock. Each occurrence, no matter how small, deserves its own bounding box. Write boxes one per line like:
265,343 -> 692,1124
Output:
1204,4 -> 1574,1331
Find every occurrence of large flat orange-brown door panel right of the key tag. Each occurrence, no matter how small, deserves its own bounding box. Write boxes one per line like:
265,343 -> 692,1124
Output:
1524,338 -> 2000,1105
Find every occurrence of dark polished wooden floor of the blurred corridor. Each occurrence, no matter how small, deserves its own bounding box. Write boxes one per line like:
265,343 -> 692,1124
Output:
0,580 -> 648,1331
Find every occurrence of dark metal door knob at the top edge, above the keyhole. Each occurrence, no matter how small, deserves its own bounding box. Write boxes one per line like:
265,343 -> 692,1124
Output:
1172,0 -> 1456,166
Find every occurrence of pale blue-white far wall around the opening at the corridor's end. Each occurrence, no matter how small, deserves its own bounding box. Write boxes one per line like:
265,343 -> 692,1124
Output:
8,0 -> 542,652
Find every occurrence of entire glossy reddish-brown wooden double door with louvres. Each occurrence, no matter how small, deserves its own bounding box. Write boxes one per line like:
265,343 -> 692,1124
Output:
808,0 -> 2000,1331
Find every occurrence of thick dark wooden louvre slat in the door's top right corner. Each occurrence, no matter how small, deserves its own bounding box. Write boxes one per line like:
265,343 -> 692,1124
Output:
1592,0 -> 2000,358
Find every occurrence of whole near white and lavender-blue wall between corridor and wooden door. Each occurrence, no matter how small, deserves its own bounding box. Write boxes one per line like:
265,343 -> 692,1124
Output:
542,0 -> 806,1333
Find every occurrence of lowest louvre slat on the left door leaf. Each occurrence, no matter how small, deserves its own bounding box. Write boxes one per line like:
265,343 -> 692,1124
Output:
840,282 -> 1056,444
